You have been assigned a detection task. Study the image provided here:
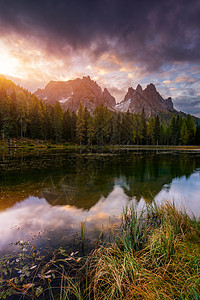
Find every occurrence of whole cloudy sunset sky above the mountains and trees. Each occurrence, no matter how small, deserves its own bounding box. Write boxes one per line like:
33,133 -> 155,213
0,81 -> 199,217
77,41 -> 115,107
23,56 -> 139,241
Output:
0,0 -> 200,116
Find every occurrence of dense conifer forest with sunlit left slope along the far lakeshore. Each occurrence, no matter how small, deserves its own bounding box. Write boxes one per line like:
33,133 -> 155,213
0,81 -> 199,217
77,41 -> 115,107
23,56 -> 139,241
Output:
0,84 -> 200,146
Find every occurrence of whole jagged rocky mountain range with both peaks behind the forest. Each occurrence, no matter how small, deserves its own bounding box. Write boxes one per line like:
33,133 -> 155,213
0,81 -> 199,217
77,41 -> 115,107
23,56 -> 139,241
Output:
34,76 -> 176,117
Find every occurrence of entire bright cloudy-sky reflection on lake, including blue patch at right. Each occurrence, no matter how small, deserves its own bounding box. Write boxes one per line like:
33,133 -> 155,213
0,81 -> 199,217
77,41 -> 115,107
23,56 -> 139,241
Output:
0,171 -> 200,251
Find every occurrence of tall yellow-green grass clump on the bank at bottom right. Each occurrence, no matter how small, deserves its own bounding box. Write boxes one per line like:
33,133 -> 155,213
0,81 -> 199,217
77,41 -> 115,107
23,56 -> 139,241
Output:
85,203 -> 200,299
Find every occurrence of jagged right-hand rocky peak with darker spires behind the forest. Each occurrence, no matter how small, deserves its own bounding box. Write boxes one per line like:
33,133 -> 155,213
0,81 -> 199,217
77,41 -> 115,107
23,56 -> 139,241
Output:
115,83 -> 174,116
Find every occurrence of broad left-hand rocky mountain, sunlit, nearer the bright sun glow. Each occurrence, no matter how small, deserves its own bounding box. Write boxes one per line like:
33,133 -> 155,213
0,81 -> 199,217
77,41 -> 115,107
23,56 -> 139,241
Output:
34,76 -> 116,111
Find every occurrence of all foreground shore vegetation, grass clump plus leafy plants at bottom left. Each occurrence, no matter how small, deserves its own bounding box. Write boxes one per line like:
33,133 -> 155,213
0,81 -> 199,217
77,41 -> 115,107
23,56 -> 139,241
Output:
0,202 -> 200,300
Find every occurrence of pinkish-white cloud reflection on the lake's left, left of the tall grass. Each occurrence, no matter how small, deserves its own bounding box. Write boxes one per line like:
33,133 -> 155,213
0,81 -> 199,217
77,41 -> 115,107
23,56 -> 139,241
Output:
0,186 -> 129,251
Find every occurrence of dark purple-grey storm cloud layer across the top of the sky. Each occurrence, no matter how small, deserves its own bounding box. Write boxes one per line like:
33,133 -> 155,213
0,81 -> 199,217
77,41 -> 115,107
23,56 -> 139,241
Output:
0,0 -> 200,70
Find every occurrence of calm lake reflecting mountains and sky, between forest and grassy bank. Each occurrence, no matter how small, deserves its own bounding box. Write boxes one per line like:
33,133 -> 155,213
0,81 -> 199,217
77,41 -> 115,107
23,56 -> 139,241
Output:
0,149 -> 200,255
